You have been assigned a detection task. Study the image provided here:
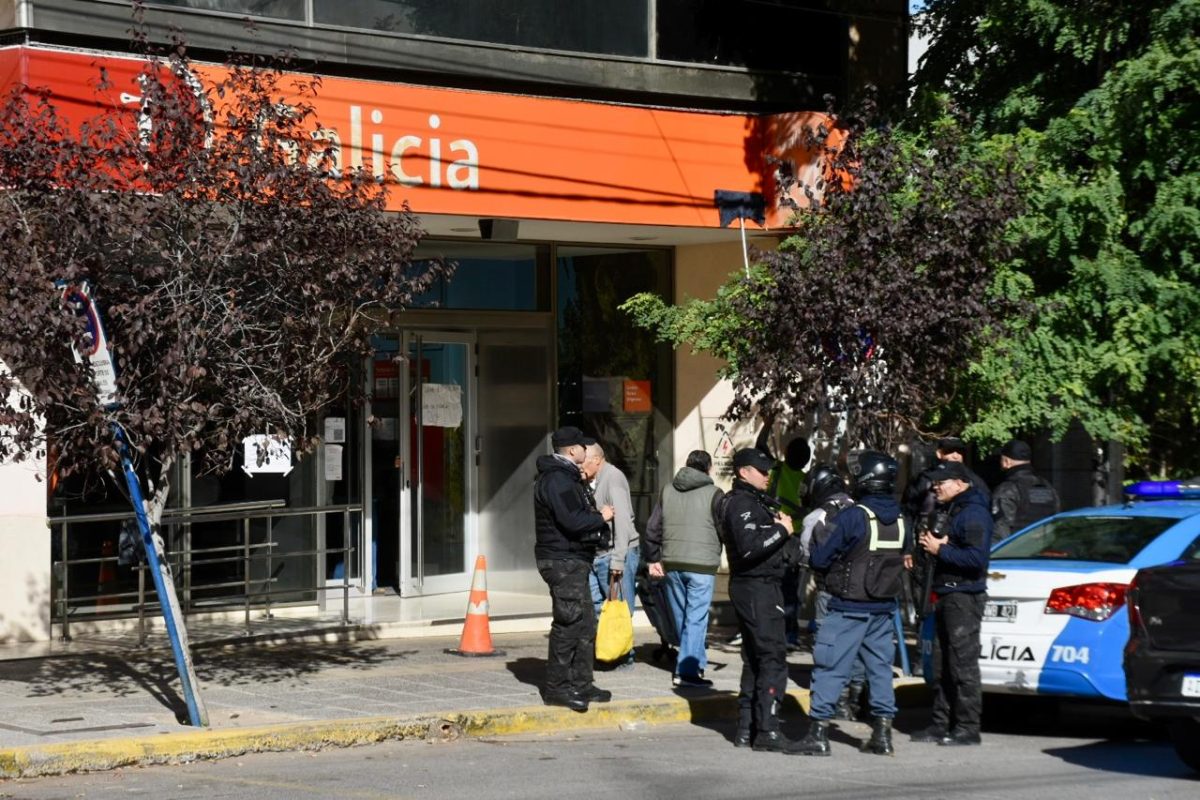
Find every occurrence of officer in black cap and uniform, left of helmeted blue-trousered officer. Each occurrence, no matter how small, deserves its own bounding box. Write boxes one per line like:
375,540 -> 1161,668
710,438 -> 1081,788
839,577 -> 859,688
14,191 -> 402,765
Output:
721,447 -> 802,753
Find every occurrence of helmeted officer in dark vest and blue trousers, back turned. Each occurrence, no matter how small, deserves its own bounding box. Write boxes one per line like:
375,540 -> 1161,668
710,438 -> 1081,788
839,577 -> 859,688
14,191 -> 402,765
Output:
798,450 -> 907,756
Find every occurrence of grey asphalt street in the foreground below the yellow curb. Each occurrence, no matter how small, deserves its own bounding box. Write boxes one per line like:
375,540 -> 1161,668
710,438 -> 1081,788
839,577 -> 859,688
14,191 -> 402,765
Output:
7,704 -> 1200,800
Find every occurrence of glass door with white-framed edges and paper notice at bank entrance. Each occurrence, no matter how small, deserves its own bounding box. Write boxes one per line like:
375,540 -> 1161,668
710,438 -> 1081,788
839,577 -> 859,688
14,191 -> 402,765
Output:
396,331 -> 476,595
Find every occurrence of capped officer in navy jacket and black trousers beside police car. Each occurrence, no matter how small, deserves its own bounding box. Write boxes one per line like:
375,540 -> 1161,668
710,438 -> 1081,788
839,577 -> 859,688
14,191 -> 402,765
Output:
912,462 -> 992,745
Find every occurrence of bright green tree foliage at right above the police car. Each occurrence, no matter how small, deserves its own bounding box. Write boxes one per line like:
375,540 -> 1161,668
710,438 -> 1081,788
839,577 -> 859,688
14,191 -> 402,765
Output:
917,0 -> 1200,473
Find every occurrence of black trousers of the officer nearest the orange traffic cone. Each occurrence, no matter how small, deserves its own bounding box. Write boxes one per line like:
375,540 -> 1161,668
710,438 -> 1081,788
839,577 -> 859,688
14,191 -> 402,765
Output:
538,559 -> 596,694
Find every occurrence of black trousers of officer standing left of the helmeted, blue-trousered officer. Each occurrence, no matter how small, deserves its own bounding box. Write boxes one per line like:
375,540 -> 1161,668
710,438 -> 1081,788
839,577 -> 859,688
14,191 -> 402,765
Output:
730,576 -> 787,730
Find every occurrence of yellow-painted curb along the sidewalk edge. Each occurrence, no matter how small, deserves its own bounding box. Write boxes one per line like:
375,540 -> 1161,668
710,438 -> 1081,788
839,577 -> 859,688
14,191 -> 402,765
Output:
0,682 -> 925,778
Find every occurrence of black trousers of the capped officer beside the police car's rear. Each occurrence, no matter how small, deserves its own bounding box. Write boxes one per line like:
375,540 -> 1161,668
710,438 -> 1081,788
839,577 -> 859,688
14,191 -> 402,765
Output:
934,591 -> 988,735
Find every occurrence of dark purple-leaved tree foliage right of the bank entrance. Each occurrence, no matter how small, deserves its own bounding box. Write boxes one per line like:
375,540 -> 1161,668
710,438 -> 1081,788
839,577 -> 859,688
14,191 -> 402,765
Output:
624,109 -> 1020,447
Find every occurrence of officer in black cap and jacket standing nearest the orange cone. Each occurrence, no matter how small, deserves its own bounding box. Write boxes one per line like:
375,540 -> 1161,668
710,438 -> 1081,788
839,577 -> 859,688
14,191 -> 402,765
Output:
534,427 -> 613,711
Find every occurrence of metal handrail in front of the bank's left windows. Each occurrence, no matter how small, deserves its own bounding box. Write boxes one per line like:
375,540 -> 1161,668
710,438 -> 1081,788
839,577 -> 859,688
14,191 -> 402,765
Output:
47,500 -> 362,645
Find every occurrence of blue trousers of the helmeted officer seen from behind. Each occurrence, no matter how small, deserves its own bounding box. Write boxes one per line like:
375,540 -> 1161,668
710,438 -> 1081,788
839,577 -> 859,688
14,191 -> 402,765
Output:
810,608 -> 896,720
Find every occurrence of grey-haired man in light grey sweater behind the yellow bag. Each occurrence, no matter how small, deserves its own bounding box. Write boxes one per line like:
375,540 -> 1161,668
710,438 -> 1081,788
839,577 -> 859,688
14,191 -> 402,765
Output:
582,443 -> 640,663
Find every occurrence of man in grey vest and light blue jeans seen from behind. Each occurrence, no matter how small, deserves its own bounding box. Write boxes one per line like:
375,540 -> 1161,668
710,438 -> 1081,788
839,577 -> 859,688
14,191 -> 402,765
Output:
646,450 -> 721,686
